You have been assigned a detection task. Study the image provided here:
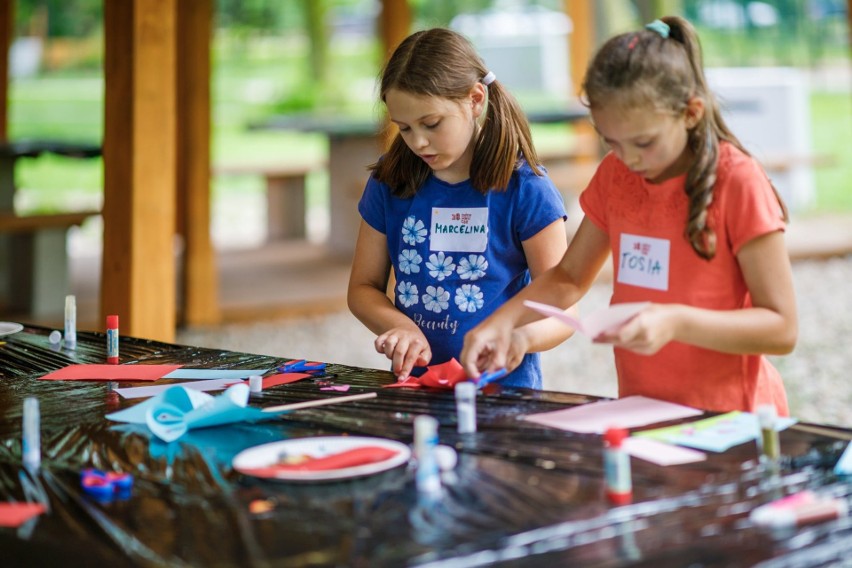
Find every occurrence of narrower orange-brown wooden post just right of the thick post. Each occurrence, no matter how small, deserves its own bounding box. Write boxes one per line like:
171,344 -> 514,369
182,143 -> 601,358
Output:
177,0 -> 220,325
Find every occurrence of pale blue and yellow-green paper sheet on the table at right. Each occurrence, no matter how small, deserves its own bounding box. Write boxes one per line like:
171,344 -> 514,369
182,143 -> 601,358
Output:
634,411 -> 796,452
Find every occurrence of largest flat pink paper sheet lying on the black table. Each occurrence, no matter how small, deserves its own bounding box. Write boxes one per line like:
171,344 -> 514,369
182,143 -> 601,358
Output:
524,396 -> 703,434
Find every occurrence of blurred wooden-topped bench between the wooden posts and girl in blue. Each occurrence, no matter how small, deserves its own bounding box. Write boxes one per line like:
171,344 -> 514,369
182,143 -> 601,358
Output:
213,161 -> 326,241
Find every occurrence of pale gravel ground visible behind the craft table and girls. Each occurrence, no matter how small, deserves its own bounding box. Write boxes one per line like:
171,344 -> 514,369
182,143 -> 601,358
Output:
177,256 -> 852,427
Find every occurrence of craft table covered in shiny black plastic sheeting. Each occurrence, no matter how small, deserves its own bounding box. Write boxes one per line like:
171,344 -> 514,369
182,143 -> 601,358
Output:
0,326 -> 852,567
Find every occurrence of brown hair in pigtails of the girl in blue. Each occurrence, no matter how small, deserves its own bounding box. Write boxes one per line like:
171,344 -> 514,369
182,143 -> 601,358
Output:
370,28 -> 541,198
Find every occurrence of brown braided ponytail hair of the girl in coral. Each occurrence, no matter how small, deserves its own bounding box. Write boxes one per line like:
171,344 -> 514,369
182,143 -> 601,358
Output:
583,16 -> 787,260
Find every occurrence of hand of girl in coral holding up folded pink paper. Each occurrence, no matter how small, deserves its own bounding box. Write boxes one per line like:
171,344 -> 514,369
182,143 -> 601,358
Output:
594,304 -> 675,355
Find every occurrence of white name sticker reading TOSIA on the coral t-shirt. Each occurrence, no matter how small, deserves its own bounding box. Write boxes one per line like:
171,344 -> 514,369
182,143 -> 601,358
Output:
618,233 -> 671,290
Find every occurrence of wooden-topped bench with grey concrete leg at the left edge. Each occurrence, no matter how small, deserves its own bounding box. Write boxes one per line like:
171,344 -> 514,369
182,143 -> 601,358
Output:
0,211 -> 100,318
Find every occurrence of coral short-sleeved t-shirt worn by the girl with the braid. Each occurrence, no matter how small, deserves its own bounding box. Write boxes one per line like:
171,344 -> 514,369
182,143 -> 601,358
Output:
580,142 -> 789,416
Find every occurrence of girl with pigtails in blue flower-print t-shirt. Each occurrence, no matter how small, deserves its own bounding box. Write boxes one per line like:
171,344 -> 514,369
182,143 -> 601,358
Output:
348,28 -> 571,388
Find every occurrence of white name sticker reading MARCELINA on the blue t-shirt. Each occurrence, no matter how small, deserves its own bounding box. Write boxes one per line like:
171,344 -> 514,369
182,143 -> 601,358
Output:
429,207 -> 488,252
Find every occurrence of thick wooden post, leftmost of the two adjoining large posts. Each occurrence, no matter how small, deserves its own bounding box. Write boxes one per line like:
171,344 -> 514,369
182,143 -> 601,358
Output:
101,0 -> 178,341
